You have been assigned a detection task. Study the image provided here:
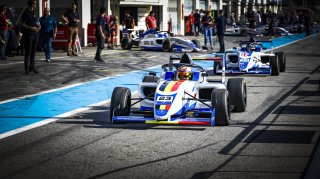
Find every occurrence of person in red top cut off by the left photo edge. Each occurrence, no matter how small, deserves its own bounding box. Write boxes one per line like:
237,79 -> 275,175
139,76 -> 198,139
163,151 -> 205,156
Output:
0,5 -> 11,60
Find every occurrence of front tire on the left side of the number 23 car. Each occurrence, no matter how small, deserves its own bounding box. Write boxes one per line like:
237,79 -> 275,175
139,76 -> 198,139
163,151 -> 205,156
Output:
110,87 -> 131,122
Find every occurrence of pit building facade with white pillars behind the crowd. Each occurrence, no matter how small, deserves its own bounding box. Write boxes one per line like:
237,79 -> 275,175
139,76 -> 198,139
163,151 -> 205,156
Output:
1,0 -> 281,45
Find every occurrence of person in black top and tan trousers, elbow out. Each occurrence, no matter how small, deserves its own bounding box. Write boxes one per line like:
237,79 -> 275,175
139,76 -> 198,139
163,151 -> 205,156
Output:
62,3 -> 80,56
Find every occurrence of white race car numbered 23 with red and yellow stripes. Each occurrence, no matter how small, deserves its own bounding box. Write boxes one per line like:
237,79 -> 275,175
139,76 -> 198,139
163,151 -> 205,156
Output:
110,54 -> 247,126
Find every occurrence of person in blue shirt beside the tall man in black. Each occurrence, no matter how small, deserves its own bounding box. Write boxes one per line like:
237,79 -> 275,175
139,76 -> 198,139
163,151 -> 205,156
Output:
39,8 -> 57,62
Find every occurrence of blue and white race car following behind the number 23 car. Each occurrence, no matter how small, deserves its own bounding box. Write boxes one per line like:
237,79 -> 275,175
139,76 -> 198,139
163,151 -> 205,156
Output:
214,37 -> 286,76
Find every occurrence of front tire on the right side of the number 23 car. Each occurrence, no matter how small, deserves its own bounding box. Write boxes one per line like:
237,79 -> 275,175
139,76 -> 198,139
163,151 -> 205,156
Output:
211,89 -> 230,126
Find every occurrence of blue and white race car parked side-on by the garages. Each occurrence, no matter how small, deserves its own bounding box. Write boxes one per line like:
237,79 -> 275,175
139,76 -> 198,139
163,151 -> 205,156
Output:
121,29 -> 206,52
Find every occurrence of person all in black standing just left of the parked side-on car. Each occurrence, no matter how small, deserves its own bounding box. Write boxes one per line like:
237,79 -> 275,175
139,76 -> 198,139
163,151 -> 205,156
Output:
94,7 -> 107,62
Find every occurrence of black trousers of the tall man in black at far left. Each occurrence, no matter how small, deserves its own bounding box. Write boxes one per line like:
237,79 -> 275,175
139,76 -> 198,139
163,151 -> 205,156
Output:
23,34 -> 38,71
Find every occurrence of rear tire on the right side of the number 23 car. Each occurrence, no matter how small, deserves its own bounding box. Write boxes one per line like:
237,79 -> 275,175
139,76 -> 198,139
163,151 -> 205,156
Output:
227,78 -> 247,112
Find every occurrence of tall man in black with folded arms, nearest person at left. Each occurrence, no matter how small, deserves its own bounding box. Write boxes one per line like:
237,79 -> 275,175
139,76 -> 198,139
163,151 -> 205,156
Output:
21,0 -> 41,74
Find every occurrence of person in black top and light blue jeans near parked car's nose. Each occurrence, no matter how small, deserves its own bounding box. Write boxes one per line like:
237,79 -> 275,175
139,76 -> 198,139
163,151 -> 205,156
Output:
201,11 -> 213,50
